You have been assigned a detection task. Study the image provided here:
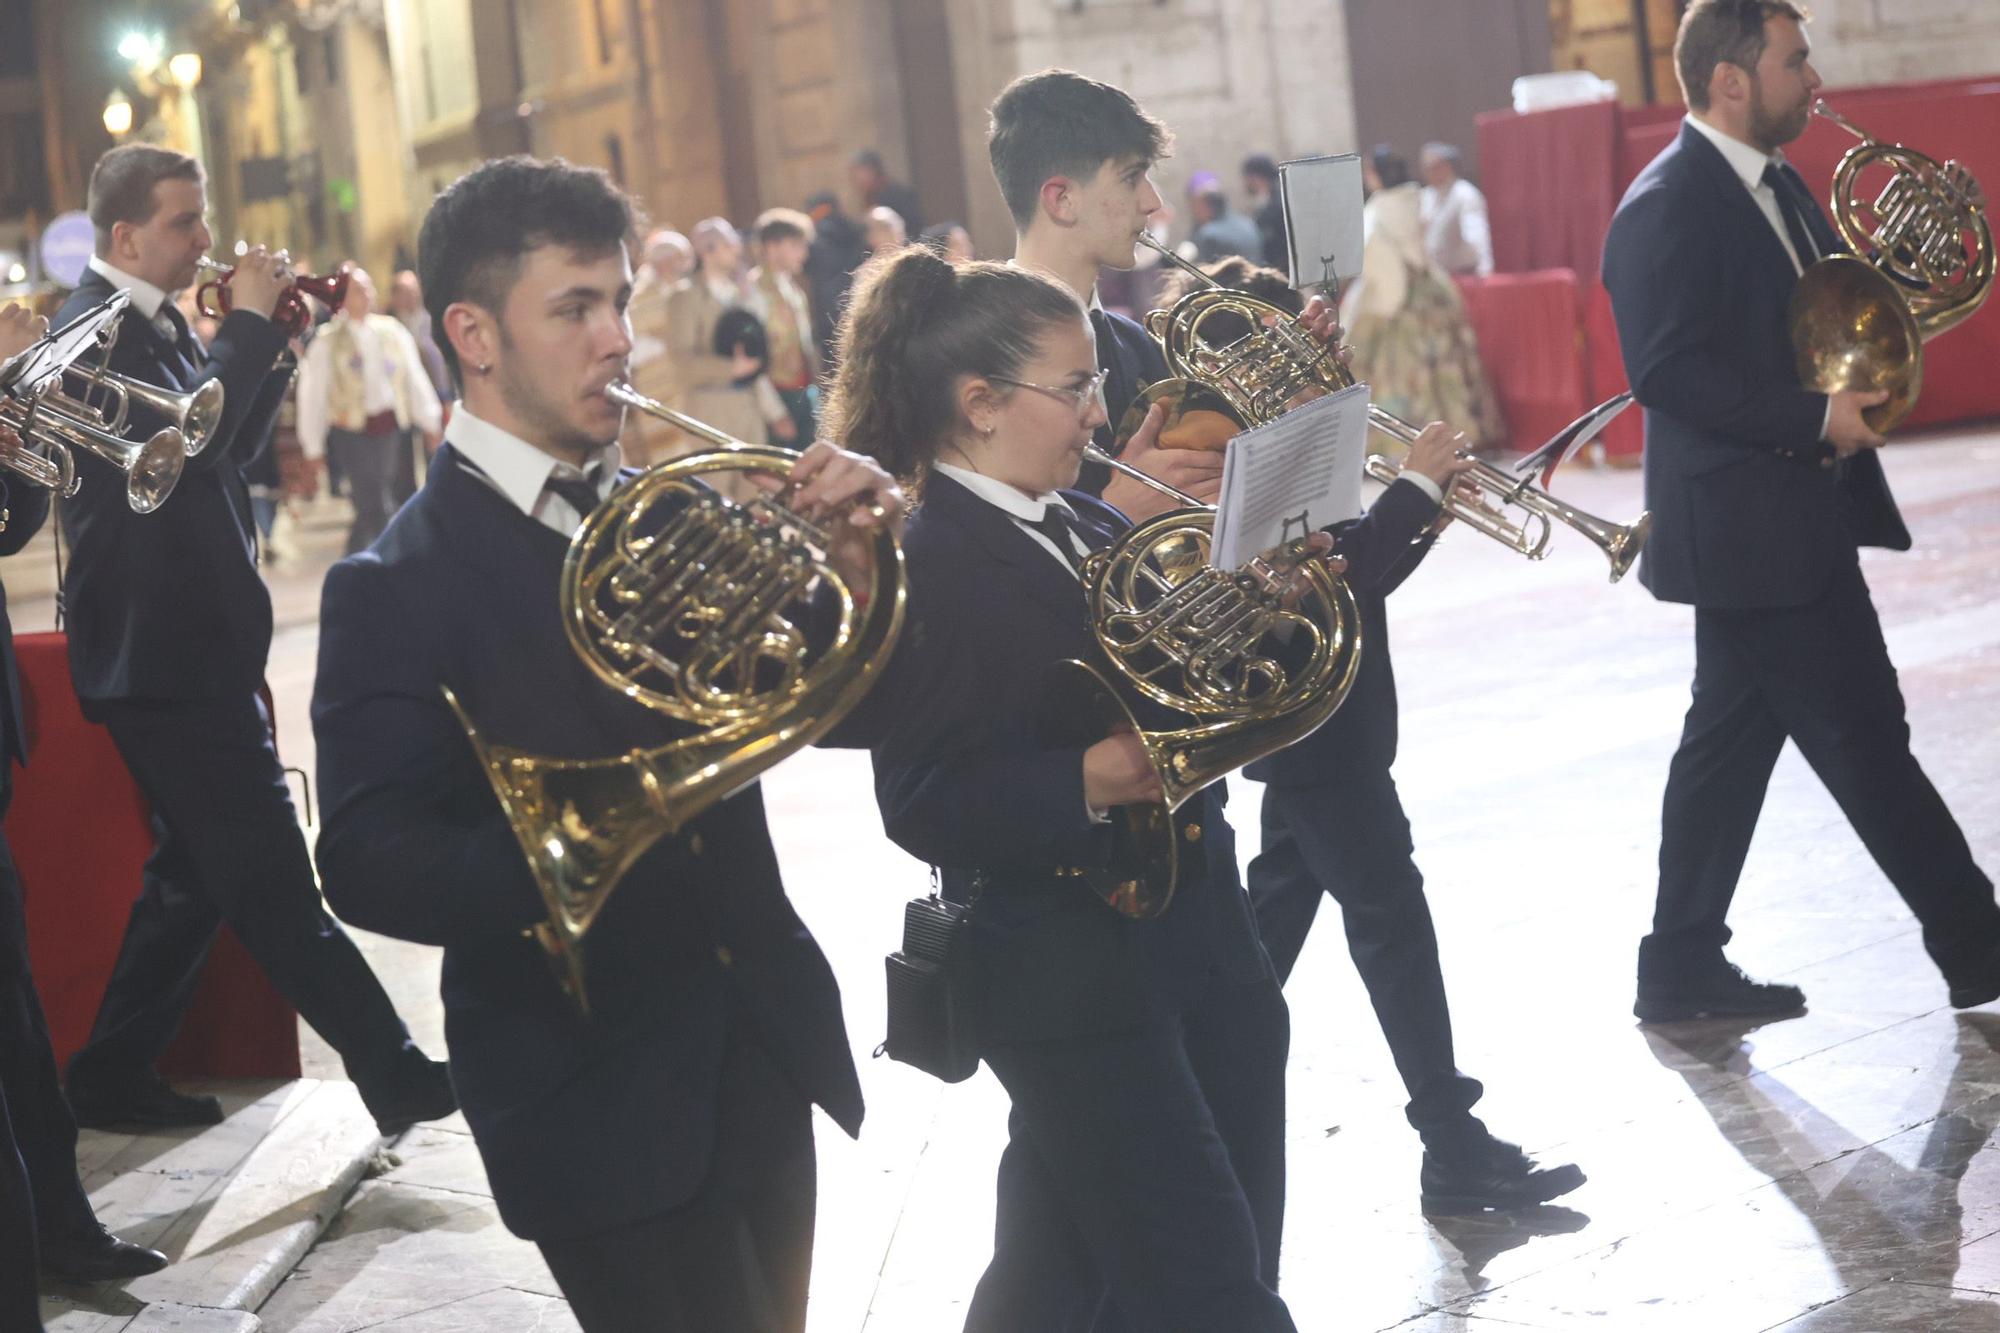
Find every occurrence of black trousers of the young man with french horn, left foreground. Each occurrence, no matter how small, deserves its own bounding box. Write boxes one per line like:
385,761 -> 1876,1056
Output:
540,1029 -> 816,1333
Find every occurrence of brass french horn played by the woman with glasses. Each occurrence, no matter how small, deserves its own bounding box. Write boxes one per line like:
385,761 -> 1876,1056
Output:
1046,446 -> 1362,917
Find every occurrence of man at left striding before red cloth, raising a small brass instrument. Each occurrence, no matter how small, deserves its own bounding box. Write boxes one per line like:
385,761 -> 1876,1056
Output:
48,144 -> 456,1133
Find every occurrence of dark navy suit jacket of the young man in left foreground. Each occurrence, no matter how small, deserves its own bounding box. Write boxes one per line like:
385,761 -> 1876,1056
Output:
312,446 -> 862,1241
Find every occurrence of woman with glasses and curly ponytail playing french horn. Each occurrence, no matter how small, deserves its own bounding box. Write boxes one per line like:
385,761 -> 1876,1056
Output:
828,248 -> 1456,1333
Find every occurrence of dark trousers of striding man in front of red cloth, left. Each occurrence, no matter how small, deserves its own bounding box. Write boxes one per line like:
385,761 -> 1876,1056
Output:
68,695 -> 414,1099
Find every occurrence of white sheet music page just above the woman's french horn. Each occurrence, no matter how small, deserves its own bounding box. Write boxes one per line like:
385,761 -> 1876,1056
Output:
1208,384 -> 1368,568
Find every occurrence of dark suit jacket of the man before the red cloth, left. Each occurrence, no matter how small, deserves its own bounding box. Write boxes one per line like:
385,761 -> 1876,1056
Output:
56,272 -> 290,703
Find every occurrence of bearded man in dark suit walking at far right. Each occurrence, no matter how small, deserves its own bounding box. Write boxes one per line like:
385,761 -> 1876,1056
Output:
1604,0 -> 2000,1021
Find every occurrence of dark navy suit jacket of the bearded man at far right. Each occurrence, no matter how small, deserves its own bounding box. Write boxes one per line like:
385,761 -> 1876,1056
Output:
1604,126 -> 1910,608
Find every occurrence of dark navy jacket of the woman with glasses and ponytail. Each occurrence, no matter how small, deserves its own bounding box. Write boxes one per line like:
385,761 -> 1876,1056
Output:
840,474 -> 1270,1041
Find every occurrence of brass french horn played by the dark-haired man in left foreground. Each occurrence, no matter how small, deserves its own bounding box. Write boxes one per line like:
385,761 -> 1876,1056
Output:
444,384 -> 904,1000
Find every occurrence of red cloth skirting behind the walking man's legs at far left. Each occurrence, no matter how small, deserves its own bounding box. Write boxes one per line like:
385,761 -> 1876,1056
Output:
6,634 -> 298,1079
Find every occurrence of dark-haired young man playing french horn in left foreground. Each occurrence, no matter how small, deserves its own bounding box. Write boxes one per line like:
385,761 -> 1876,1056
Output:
312,158 -> 900,1333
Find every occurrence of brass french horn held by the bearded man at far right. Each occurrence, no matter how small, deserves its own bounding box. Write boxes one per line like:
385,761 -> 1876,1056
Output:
1790,100 -> 1994,432
